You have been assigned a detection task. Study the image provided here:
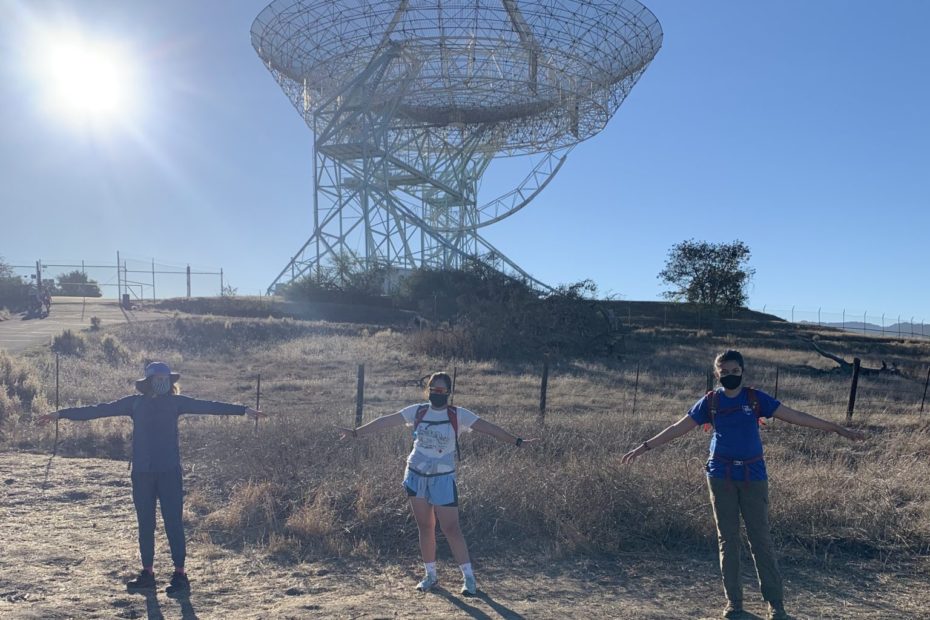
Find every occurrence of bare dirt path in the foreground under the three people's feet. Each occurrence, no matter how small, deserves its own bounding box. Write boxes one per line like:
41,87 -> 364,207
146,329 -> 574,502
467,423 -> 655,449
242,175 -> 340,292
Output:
0,453 -> 930,620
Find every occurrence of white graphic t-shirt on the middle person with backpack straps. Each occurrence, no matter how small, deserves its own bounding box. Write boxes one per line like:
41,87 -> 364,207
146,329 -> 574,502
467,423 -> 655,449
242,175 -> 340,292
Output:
400,403 -> 478,475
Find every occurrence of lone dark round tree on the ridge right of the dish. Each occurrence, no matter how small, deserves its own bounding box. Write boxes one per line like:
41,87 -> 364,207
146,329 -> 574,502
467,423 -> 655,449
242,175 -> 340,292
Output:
658,239 -> 756,308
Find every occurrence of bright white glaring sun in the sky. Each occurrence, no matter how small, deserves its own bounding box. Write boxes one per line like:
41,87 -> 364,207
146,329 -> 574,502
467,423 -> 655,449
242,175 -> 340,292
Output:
34,32 -> 134,125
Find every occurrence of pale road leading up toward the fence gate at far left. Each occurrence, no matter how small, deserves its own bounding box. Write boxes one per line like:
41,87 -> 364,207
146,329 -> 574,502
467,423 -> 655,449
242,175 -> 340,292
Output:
0,297 -> 165,353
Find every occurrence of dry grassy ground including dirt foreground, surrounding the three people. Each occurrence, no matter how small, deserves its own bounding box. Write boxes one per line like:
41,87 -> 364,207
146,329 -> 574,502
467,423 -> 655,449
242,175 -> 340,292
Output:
0,308 -> 930,618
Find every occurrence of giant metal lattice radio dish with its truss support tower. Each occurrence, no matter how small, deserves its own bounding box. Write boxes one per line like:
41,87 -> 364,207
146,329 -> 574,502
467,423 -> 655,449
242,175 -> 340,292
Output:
252,0 -> 662,291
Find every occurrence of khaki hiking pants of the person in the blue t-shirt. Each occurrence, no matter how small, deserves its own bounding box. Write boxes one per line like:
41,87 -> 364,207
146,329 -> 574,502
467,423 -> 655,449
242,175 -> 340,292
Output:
707,478 -> 783,602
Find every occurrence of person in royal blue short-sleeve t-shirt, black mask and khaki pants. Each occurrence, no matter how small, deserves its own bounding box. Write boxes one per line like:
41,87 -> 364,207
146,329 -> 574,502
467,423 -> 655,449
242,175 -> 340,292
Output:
622,350 -> 865,620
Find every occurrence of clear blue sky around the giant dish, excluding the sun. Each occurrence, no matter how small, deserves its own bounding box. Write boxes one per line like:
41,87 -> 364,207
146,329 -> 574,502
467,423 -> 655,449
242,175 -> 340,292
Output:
0,0 -> 930,323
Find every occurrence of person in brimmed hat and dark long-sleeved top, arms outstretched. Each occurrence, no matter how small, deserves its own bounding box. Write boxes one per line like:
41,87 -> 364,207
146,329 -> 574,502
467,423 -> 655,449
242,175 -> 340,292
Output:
36,362 -> 265,596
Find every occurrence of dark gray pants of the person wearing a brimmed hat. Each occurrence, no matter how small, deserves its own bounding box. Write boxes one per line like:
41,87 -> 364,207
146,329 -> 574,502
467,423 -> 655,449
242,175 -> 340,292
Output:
132,469 -> 187,568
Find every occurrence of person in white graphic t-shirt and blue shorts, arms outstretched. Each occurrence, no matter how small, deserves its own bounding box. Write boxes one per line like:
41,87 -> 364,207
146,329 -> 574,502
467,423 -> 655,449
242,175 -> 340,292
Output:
340,372 -> 535,596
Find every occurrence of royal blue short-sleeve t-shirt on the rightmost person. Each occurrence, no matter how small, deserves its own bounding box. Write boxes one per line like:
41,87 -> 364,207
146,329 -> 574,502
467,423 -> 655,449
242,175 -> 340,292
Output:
688,388 -> 781,481
